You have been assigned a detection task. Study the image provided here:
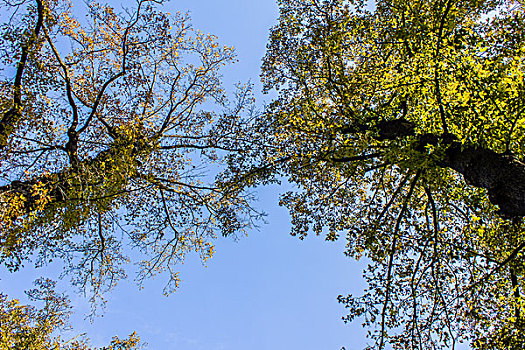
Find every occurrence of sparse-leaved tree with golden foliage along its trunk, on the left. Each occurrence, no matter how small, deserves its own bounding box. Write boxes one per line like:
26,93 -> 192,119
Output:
0,0 -> 258,300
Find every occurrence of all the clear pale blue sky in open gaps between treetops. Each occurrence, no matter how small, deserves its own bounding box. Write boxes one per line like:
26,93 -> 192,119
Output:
0,0 -> 366,350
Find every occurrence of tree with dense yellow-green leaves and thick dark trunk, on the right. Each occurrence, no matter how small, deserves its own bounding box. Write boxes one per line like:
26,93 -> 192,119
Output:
229,0 -> 525,349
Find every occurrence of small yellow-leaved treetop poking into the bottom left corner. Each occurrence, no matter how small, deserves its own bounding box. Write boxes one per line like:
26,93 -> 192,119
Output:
0,279 -> 139,350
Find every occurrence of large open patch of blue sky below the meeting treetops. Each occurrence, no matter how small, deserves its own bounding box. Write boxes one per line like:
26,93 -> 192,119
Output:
62,188 -> 365,350
